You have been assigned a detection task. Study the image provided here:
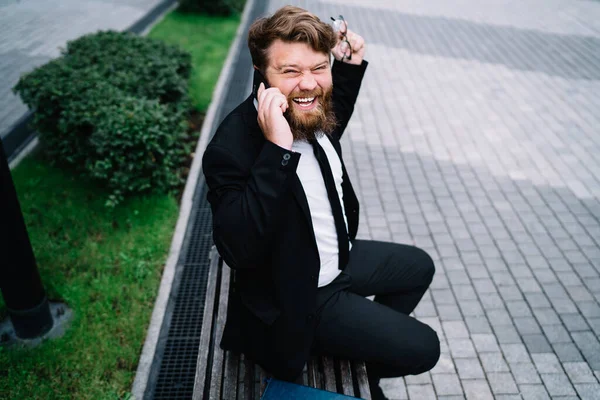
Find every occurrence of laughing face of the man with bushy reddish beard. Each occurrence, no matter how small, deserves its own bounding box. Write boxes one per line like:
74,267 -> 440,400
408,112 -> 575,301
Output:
265,39 -> 335,140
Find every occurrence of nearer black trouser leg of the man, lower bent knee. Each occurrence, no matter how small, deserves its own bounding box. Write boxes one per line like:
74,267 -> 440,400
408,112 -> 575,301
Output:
315,291 -> 439,378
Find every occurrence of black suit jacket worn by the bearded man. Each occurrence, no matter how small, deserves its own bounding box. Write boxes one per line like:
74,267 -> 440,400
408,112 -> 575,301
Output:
203,61 -> 367,380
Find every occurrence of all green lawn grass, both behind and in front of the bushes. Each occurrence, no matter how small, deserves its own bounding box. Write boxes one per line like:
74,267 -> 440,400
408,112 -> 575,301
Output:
0,7 -> 239,399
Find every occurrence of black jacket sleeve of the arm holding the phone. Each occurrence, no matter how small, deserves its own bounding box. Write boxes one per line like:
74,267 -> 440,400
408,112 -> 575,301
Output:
202,136 -> 300,269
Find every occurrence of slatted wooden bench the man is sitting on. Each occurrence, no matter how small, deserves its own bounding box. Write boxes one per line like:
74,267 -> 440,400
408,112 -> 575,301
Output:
193,246 -> 371,400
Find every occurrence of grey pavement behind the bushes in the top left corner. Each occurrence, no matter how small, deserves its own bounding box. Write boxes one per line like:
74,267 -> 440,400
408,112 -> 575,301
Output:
0,0 -> 162,141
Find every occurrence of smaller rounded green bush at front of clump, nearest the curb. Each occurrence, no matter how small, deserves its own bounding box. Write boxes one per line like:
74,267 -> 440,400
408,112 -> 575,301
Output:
86,97 -> 187,205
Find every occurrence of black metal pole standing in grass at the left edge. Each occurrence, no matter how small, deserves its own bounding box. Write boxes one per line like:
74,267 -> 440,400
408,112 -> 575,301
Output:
0,139 -> 53,339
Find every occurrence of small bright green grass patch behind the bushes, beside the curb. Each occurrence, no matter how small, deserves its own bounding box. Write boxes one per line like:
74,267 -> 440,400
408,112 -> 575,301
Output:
148,12 -> 240,112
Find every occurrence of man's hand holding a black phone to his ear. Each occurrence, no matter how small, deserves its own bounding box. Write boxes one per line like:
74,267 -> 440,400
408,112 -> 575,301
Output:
256,82 -> 294,150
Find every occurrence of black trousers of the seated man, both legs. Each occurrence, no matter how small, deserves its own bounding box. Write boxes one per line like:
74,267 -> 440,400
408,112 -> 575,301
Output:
314,240 -> 440,382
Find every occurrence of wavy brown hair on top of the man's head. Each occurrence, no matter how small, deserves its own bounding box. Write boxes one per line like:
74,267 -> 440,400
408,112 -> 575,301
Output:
248,6 -> 337,72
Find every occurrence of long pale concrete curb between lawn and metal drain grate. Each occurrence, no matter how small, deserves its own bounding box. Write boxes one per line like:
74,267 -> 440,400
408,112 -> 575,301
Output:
131,0 -> 254,399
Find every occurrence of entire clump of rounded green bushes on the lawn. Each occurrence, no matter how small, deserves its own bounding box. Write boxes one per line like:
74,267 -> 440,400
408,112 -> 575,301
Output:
14,32 -> 191,205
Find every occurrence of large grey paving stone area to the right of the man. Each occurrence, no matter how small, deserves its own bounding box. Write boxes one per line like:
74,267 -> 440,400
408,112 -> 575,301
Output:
269,0 -> 600,399
